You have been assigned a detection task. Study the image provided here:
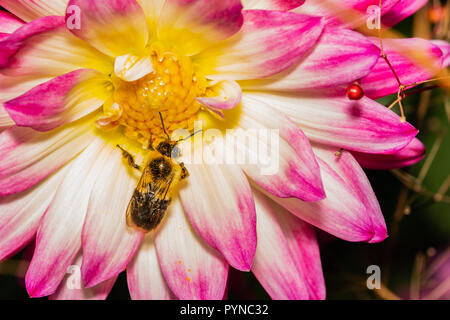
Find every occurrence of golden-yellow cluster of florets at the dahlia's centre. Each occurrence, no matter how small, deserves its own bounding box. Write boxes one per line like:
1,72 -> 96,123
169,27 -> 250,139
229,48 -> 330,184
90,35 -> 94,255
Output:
97,45 -> 207,147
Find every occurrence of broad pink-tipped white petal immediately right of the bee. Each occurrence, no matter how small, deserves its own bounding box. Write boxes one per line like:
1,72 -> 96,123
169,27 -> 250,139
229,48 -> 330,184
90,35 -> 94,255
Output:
180,146 -> 256,271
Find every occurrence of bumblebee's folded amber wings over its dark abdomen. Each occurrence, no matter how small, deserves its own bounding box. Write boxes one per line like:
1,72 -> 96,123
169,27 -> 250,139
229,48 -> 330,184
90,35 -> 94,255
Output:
127,168 -> 175,231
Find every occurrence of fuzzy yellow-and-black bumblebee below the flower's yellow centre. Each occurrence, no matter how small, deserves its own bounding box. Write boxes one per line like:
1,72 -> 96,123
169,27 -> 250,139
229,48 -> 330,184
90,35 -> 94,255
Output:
117,114 -> 189,233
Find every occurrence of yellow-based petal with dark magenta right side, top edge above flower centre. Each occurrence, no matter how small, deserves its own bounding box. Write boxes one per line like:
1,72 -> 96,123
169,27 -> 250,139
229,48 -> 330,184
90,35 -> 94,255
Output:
158,0 -> 243,56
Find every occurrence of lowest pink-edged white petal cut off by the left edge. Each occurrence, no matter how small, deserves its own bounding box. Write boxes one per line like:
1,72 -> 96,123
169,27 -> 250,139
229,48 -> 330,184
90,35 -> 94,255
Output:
0,168 -> 67,261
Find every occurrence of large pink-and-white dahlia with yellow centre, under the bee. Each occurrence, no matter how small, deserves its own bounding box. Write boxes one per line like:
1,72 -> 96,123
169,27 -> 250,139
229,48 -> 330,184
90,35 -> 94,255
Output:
0,0 -> 449,299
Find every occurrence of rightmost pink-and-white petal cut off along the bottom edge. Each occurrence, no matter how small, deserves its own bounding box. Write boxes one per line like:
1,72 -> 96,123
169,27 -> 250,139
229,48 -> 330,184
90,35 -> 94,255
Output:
252,191 -> 325,300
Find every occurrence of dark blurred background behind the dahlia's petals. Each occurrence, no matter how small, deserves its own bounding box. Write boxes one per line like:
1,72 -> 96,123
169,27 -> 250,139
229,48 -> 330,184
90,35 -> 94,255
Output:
0,1 -> 450,299
